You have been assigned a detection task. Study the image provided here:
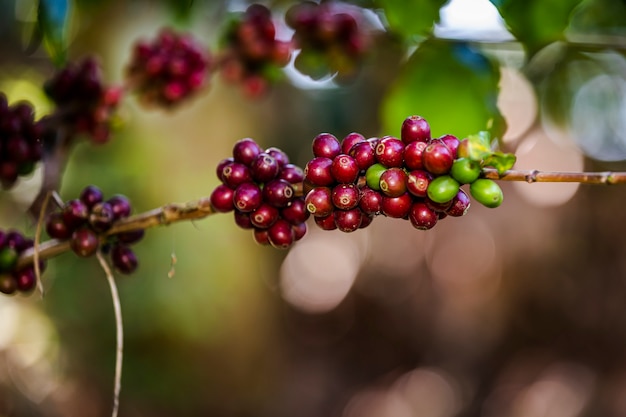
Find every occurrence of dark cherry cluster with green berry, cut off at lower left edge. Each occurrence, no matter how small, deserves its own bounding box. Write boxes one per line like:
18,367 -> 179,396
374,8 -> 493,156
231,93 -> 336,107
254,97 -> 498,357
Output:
0,230 -> 46,294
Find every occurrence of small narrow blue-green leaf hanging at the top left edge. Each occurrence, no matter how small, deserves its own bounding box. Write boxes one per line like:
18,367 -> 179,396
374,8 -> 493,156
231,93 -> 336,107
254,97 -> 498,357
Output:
37,0 -> 71,66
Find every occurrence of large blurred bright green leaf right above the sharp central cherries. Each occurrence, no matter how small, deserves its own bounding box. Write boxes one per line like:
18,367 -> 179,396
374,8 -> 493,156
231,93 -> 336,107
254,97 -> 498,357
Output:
382,39 -> 505,138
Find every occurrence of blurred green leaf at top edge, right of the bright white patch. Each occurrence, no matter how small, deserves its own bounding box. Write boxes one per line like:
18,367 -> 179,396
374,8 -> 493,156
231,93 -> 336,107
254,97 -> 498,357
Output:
490,0 -> 582,56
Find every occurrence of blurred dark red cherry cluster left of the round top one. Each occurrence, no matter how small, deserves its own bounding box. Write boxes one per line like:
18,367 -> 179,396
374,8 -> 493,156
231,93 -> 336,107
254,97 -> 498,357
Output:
44,57 -> 122,143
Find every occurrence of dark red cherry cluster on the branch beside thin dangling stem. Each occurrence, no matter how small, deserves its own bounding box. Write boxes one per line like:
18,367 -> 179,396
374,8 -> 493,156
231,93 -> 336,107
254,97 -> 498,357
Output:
46,185 -> 144,274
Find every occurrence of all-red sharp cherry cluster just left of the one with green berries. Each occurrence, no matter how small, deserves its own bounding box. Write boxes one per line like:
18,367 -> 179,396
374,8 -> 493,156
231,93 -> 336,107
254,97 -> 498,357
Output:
210,138 -> 309,249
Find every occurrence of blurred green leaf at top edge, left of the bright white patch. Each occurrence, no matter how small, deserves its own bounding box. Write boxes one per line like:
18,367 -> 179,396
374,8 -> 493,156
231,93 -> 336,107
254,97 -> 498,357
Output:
377,0 -> 448,38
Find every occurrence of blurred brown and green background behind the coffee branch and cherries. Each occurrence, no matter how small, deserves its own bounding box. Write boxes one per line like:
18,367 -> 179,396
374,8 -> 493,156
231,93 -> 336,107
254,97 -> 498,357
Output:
0,0 -> 626,417
